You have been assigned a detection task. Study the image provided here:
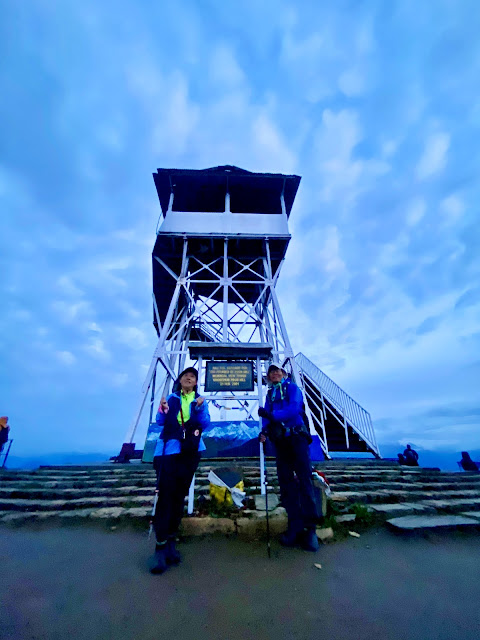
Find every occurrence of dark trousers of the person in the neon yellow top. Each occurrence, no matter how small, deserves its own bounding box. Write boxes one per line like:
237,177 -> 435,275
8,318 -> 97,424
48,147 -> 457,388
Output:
153,453 -> 200,542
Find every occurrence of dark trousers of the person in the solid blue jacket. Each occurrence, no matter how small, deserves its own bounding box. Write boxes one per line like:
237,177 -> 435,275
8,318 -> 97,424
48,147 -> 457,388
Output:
275,434 -> 317,531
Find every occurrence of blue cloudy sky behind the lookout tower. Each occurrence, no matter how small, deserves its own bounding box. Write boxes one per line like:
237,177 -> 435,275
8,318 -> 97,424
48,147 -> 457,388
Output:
0,0 -> 480,456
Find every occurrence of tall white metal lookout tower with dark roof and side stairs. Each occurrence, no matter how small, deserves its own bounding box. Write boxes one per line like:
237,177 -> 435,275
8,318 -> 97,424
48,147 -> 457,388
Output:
121,165 -> 379,456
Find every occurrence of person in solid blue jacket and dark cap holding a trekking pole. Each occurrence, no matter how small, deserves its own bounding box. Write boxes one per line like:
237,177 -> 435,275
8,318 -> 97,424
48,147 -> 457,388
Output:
258,364 -> 319,551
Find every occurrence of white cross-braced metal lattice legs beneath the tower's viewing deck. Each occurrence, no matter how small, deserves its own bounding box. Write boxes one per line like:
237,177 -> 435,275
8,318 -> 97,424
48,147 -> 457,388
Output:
126,236 -> 327,452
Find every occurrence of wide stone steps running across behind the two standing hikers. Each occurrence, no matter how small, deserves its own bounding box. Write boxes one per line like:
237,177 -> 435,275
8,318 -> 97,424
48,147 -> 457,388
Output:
0,459 -> 480,529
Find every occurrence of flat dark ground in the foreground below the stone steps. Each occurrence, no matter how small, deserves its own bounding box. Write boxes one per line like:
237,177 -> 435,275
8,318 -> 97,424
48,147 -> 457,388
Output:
0,527 -> 480,640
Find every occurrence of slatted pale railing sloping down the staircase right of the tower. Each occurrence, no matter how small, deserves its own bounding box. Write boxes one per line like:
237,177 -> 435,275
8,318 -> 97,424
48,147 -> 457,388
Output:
295,353 -> 380,455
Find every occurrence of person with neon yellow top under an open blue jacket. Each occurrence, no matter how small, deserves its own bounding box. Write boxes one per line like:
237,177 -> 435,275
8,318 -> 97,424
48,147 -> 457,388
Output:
150,367 -> 210,573
